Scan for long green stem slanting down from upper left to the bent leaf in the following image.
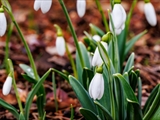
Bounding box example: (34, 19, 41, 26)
(5, 7, 39, 80)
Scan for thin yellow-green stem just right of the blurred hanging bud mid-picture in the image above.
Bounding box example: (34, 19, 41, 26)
(65, 43, 78, 78)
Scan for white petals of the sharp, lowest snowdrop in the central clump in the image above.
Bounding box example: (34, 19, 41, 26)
(89, 73, 104, 100)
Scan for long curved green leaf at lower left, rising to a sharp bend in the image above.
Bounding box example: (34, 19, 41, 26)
(25, 69, 51, 120)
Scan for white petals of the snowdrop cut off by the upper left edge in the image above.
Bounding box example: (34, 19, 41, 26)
(0, 13, 7, 36)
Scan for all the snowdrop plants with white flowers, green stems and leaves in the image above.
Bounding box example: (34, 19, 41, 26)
(0, 0, 160, 120)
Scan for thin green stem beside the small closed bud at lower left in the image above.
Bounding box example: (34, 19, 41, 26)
(8, 59, 24, 114)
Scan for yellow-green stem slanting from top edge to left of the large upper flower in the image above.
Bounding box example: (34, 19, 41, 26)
(96, 0, 109, 32)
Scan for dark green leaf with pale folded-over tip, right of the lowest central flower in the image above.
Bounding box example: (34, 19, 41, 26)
(113, 73, 138, 103)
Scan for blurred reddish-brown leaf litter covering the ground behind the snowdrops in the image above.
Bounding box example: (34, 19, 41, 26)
(0, 0, 160, 120)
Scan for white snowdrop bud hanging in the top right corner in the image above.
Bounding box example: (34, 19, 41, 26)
(144, 2, 157, 26)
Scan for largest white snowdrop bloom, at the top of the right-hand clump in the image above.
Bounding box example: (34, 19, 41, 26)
(109, 4, 126, 35)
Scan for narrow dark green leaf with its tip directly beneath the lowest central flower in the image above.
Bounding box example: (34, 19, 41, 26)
(94, 101, 113, 120)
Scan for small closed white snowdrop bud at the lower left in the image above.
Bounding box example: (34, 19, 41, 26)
(2, 76, 12, 95)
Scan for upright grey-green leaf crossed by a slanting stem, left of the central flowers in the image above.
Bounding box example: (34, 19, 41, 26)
(76, 42, 90, 84)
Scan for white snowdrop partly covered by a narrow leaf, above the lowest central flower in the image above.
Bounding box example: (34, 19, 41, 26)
(92, 41, 108, 66)
